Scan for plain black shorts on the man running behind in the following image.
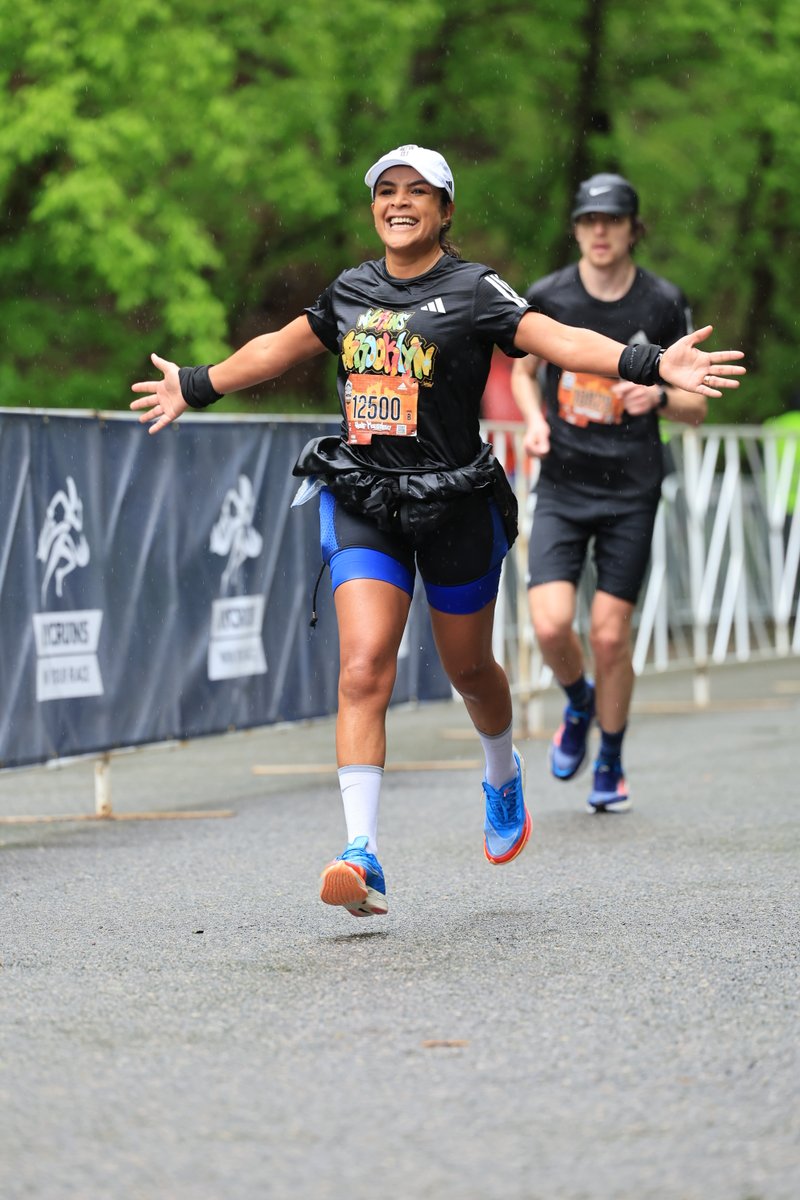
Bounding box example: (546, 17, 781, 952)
(528, 493, 658, 604)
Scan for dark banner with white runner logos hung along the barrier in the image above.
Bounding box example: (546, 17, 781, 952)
(0, 410, 450, 767)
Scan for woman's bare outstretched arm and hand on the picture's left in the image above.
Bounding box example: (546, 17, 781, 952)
(131, 314, 325, 433)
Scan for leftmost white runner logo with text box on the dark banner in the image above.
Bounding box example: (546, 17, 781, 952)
(34, 475, 103, 703)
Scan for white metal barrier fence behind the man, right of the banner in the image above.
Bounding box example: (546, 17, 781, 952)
(485, 422, 800, 730)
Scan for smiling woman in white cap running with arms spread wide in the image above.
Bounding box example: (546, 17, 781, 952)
(131, 144, 742, 917)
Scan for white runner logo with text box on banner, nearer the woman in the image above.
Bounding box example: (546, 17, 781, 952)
(209, 475, 266, 680)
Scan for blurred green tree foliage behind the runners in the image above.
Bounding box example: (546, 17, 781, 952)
(0, 0, 800, 420)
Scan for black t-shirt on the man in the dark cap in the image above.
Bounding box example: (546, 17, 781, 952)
(525, 264, 692, 502)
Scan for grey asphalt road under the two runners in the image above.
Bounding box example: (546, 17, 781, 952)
(0, 660, 800, 1200)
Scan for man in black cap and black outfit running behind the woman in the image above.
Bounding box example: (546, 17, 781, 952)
(511, 174, 706, 812)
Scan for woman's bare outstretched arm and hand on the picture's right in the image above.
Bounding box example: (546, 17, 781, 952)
(515, 312, 745, 396)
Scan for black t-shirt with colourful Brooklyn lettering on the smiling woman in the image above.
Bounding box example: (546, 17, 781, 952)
(306, 254, 528, 469)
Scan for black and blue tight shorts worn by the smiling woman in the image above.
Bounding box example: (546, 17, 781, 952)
(319, 488, 509, 613)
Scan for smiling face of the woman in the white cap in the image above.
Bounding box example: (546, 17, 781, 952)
(372, 167, 453, 257)
